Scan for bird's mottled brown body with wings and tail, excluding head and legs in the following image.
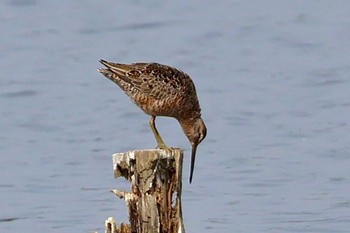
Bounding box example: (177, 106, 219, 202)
(99, 60, 200, 118)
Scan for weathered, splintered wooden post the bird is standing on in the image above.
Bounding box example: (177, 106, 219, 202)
(105, 149, 185, 233)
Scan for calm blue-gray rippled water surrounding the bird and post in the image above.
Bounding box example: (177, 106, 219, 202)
(0, 0, 350, 233)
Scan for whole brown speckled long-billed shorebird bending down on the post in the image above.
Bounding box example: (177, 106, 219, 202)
(97, 59, 207, 183)
